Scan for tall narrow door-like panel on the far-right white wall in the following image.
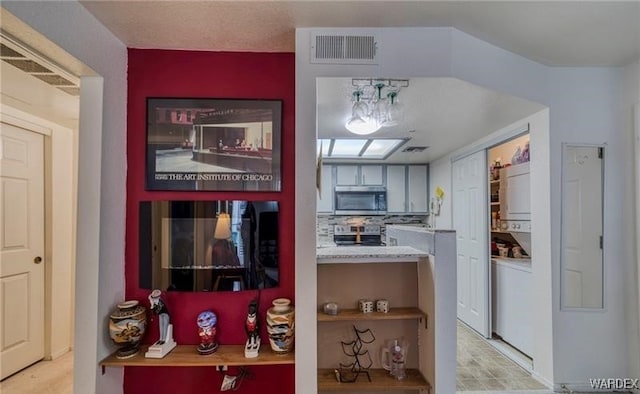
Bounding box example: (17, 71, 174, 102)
(562, 146, 603, 308)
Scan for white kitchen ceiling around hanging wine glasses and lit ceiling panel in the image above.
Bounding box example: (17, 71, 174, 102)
(316, 78, 544, 163)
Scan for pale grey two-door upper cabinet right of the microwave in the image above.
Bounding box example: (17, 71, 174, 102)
(387, 165, 428, 213)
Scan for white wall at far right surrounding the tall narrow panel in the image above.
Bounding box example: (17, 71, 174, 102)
(548, 68, 638, 389)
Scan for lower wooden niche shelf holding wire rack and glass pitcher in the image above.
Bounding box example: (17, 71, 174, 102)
(318, 369, 431, 391)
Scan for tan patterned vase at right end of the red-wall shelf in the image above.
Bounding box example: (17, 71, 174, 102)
(267, 298, 295, 353)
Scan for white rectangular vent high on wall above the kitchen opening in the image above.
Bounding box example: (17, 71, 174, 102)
(311, 34, 378, 64)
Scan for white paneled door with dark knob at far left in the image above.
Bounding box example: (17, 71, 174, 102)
(0, 123, 44, 379)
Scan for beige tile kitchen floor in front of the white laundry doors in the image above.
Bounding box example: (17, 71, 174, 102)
(456, 322, 551, 394)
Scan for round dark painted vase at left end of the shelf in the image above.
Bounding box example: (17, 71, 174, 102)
(109, 301, 147, 358)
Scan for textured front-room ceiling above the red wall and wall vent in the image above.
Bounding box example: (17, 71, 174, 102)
(80, 0, 640, 66)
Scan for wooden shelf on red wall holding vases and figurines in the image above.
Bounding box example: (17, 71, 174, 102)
(100, 345, 295, 368)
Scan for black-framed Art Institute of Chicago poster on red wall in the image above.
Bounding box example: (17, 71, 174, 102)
(146, 97, 282, 191)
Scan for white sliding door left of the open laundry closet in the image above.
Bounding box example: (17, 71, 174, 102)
(452, 150, 490, 337)
